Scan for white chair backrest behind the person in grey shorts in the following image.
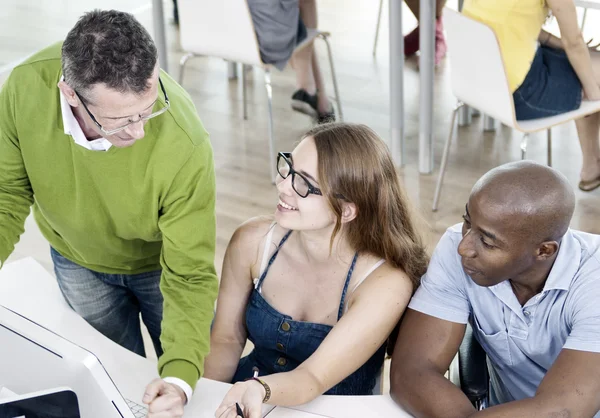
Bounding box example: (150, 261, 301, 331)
(177, 0, 262, 65)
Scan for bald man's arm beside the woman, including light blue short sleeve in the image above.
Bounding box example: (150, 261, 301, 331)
(390, 227, 475, 418)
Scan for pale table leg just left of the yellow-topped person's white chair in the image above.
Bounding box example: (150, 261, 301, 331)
(420, 0, 435, 174)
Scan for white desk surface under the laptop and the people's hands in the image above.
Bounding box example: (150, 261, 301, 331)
(0, 258, 410, 418)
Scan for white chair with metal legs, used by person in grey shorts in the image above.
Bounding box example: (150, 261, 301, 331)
(178, 0, 344, 179)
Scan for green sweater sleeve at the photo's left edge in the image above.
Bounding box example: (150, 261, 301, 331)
(0, 72, 34, 266)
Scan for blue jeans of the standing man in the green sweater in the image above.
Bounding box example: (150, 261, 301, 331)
(51, 248, 145, 356)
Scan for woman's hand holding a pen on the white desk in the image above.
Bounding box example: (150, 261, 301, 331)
(215, 380, 265, 418)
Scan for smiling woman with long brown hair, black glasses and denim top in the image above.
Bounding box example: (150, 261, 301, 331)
(205, 123, 428, 418)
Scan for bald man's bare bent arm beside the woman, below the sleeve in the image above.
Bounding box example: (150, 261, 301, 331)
(390, 309, 475, 418)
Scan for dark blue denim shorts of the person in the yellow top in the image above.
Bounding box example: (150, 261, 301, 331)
(513, 46, 582, 120)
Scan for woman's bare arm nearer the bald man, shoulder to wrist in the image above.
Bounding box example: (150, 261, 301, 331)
(261, 264, 412, 406)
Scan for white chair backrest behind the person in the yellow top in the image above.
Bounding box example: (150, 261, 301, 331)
(444, 8, 516, 126)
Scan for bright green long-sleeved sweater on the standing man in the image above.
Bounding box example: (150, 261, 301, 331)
(0, 44, 218, 388)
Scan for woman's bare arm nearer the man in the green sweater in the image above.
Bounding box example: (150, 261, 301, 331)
(204, 219, 268, 383)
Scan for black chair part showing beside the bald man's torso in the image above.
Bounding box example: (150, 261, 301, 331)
(455, 324, 490, 410)
